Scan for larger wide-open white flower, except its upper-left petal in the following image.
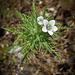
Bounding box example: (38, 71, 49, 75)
(42, 20, 58, 35)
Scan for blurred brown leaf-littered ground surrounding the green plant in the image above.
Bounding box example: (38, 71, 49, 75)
(0, 0, 75, 75)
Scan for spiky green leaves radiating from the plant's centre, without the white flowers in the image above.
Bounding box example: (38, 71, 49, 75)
(4, 1, 67, 63)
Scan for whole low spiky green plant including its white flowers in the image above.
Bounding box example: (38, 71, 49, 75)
(4, 1, 68, 62)
